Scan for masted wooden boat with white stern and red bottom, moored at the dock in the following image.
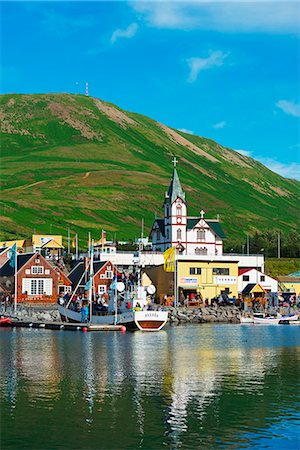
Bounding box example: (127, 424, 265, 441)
(58, 243, 168, 331)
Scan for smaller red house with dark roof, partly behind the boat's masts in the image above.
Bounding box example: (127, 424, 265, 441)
(68, 260, 121, 295)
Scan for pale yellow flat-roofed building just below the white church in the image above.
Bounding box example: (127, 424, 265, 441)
(177, 256, 238, 301)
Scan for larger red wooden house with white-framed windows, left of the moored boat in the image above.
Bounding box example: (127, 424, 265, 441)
(0, 253, 71, 303)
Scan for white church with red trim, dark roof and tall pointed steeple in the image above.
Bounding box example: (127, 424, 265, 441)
(150, 158, 225, 256)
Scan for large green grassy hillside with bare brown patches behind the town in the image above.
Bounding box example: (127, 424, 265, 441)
(0, 94, 300, 246)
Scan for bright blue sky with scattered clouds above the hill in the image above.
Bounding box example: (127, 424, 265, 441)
(0, 0, 300, 179)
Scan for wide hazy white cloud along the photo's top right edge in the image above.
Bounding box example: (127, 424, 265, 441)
(131, 0, 299, 34)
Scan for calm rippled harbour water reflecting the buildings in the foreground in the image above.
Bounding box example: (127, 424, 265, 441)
(0, 325, 300, 450)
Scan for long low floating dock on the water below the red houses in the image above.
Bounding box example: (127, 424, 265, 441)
(2, 319, 126, 332)
